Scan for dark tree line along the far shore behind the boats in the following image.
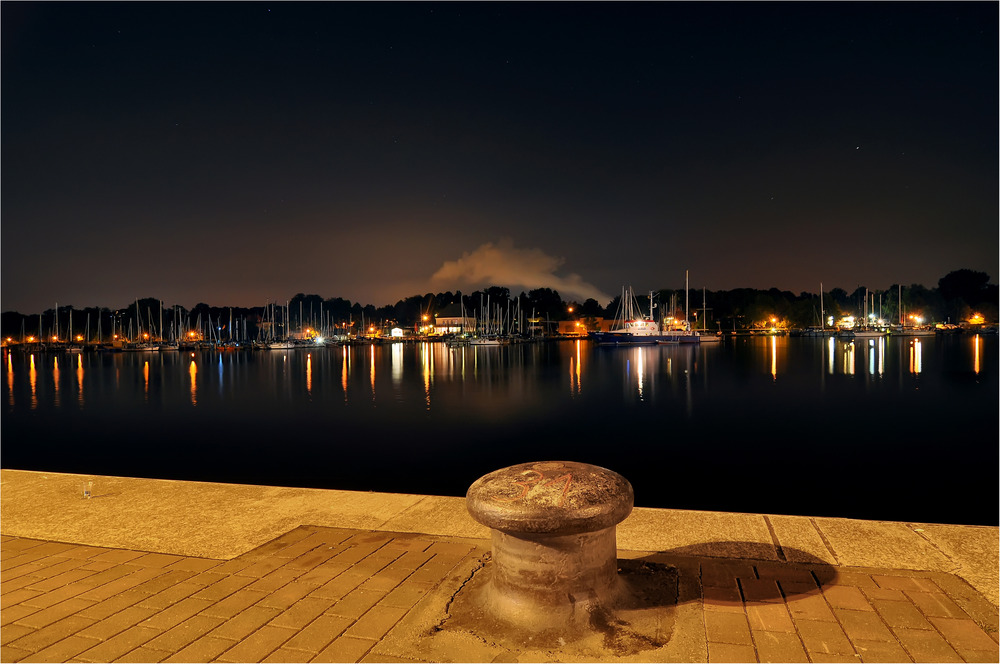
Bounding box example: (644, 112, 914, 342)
(0, 269, 998, 340)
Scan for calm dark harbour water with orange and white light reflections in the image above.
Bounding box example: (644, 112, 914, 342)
(2, 335, 1000, 525)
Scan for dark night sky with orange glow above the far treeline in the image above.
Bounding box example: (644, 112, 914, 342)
(0, 2, 1000, 313)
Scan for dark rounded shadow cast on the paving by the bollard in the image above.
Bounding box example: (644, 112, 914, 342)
(618, 541, 837, 609)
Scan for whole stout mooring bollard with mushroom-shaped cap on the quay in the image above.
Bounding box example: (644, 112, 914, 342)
(466, 461, 634, 631)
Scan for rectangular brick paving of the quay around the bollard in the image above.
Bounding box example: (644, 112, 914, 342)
(0, 526, 1000, 662)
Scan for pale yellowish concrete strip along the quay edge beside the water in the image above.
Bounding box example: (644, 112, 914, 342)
(0, 469, 1000, 606)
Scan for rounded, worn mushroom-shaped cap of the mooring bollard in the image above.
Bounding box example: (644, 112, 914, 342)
(466, 461, 634, 535)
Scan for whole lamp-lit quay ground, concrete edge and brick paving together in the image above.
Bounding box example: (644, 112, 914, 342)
(0, 470, 1000, 662)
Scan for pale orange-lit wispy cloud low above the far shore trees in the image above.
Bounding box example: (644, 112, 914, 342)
(431, 238, 611, 305)
